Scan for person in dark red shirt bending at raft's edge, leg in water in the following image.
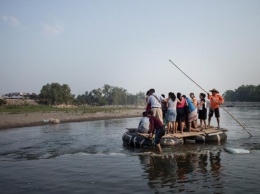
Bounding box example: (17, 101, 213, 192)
(147, 110, 165, 153)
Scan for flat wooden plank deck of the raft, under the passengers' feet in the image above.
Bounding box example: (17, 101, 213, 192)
(134, 127, 227, 139)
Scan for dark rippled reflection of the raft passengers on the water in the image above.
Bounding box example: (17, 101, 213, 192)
(139, 151, 224, 192)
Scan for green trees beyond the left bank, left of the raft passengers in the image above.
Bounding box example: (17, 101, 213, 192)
(39, 83, 145, 106)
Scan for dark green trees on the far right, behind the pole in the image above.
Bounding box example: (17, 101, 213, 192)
(224, 85, 260, 102)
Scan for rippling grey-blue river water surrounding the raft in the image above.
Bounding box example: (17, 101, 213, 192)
(0, 107, 260, 194)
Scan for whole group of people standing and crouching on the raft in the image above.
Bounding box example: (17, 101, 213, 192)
(138, 88, 224, 152)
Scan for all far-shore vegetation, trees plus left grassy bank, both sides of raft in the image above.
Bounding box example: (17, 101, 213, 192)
(0, 83, 260, 114)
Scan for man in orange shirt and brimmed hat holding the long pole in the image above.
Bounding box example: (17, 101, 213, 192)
(208, 89, 224, 129)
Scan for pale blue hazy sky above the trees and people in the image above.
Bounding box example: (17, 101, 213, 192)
(0, 0, 260, 96)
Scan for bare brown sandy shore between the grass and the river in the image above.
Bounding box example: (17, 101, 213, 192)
(0, 109, 143, 129)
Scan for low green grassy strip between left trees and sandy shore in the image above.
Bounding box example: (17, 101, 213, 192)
(0, 105, 138, 114)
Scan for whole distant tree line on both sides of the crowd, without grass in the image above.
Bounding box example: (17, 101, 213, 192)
(3, 83, 260, 106)
